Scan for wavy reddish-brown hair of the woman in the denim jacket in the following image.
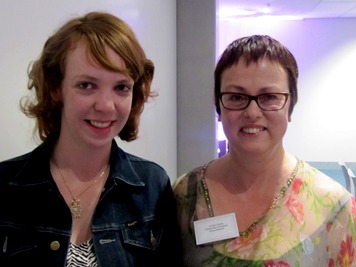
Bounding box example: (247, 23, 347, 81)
(20, 12, 154, 142)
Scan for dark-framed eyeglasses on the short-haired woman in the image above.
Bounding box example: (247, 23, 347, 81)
(218, 92, 291, 111)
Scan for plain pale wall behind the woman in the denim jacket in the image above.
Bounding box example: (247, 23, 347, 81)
(0, 0, 177, 179)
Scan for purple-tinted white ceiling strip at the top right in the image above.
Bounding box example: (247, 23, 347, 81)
(217, 0, 356, 19)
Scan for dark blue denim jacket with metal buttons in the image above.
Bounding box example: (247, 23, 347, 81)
(0, 141, 182, 267)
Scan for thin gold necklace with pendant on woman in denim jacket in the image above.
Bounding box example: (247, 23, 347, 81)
(53, 160, 108, 219)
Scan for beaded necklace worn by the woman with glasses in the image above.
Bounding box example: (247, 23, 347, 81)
(201, 159, 300, 237)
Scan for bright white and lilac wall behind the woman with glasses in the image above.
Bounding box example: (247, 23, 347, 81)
(217, 18, 356, 162)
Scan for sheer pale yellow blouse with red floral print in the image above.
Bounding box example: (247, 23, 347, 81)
(174, 161, 356, 267)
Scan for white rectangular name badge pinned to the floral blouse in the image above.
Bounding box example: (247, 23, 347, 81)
(194, 213, 239, 245)
